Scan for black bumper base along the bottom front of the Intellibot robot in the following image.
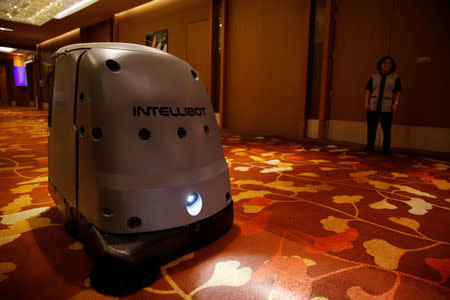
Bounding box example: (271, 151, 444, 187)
(79, 202, 233, 266)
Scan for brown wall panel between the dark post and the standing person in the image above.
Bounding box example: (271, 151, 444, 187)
(329, 0, 393, 121)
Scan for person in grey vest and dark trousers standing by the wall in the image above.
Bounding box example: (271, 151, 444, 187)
(363, 56, 402, 154)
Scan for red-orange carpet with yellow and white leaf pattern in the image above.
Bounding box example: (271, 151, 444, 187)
(0, 109, 450, 300)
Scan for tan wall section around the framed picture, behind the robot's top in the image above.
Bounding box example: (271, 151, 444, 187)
(116, 0, 212, 95)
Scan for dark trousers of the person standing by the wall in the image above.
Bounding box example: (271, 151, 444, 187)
(367, 110, 392, 152)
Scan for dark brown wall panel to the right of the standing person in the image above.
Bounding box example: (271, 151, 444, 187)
(390, 0, 450, 127)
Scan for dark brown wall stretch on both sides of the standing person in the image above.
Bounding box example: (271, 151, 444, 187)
(330, 0, 450, 128)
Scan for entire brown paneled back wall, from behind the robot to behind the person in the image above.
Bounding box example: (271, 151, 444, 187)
(29, 0, 450, 144)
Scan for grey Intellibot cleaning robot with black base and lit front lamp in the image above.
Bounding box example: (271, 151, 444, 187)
(48, 43, 233, 265)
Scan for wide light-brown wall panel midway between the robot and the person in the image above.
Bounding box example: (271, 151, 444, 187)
(223, 0, 309, 138)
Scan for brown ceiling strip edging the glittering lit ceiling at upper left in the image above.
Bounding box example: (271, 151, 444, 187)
(0, 0, 151, 49)
